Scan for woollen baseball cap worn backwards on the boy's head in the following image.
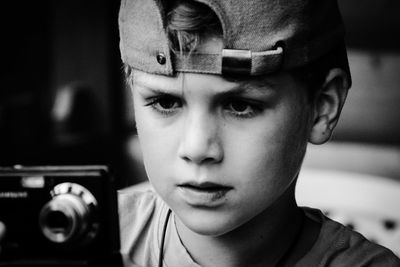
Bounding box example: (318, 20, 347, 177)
(119, 0, 350, 81)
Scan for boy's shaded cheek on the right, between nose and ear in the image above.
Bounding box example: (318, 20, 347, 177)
(228, 105, 307, 191)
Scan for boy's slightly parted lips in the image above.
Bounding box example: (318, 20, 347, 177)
(178, 182, 233, 208)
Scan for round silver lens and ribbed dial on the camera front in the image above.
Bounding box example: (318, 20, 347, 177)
(39, 183, 99, 244)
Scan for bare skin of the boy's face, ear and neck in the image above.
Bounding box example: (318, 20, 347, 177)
(132, 38, 349, 266)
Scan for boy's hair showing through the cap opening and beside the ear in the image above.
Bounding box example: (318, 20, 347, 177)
(125, 0, 332, 101)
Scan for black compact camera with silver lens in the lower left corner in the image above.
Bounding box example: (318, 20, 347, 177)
(0, 166, 121, 267)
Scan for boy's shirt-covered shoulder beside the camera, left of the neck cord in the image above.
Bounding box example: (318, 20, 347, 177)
(118, 183, 168, 266)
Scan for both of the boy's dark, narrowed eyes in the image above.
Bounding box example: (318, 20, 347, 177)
(145, 95, 263, 119)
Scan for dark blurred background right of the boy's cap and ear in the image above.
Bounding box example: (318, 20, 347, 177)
(333, 0, 400, 147)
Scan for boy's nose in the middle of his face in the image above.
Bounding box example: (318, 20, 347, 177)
(178, 113, 224, 164)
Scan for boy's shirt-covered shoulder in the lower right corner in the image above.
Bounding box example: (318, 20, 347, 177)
(300, 208, 400, 267)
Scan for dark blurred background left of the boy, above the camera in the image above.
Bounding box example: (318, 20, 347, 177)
(0, 0, 123, 170)
